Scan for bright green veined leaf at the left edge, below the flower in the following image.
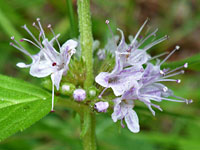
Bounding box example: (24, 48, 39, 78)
(0, 75, 51, 140)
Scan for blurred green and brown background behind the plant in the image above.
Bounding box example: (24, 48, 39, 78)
(0, 0, 200, 150)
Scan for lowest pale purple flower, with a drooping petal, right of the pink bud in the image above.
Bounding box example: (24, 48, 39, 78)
(112, 98, 140, 133)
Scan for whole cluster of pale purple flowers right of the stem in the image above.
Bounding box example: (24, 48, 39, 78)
(95, 20, 192, 133)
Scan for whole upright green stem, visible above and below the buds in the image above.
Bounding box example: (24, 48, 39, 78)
(78, 0, 96, 150)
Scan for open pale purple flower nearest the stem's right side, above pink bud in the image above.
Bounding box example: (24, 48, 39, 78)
(95, 53, 143, 97)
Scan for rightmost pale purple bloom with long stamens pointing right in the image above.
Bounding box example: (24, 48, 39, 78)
(122, 47, 192, 115)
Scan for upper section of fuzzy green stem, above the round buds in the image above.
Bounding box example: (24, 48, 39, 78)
(78, 0, 94, 89)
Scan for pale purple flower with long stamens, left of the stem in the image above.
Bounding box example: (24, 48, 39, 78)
(11, 18, 77, 111)
